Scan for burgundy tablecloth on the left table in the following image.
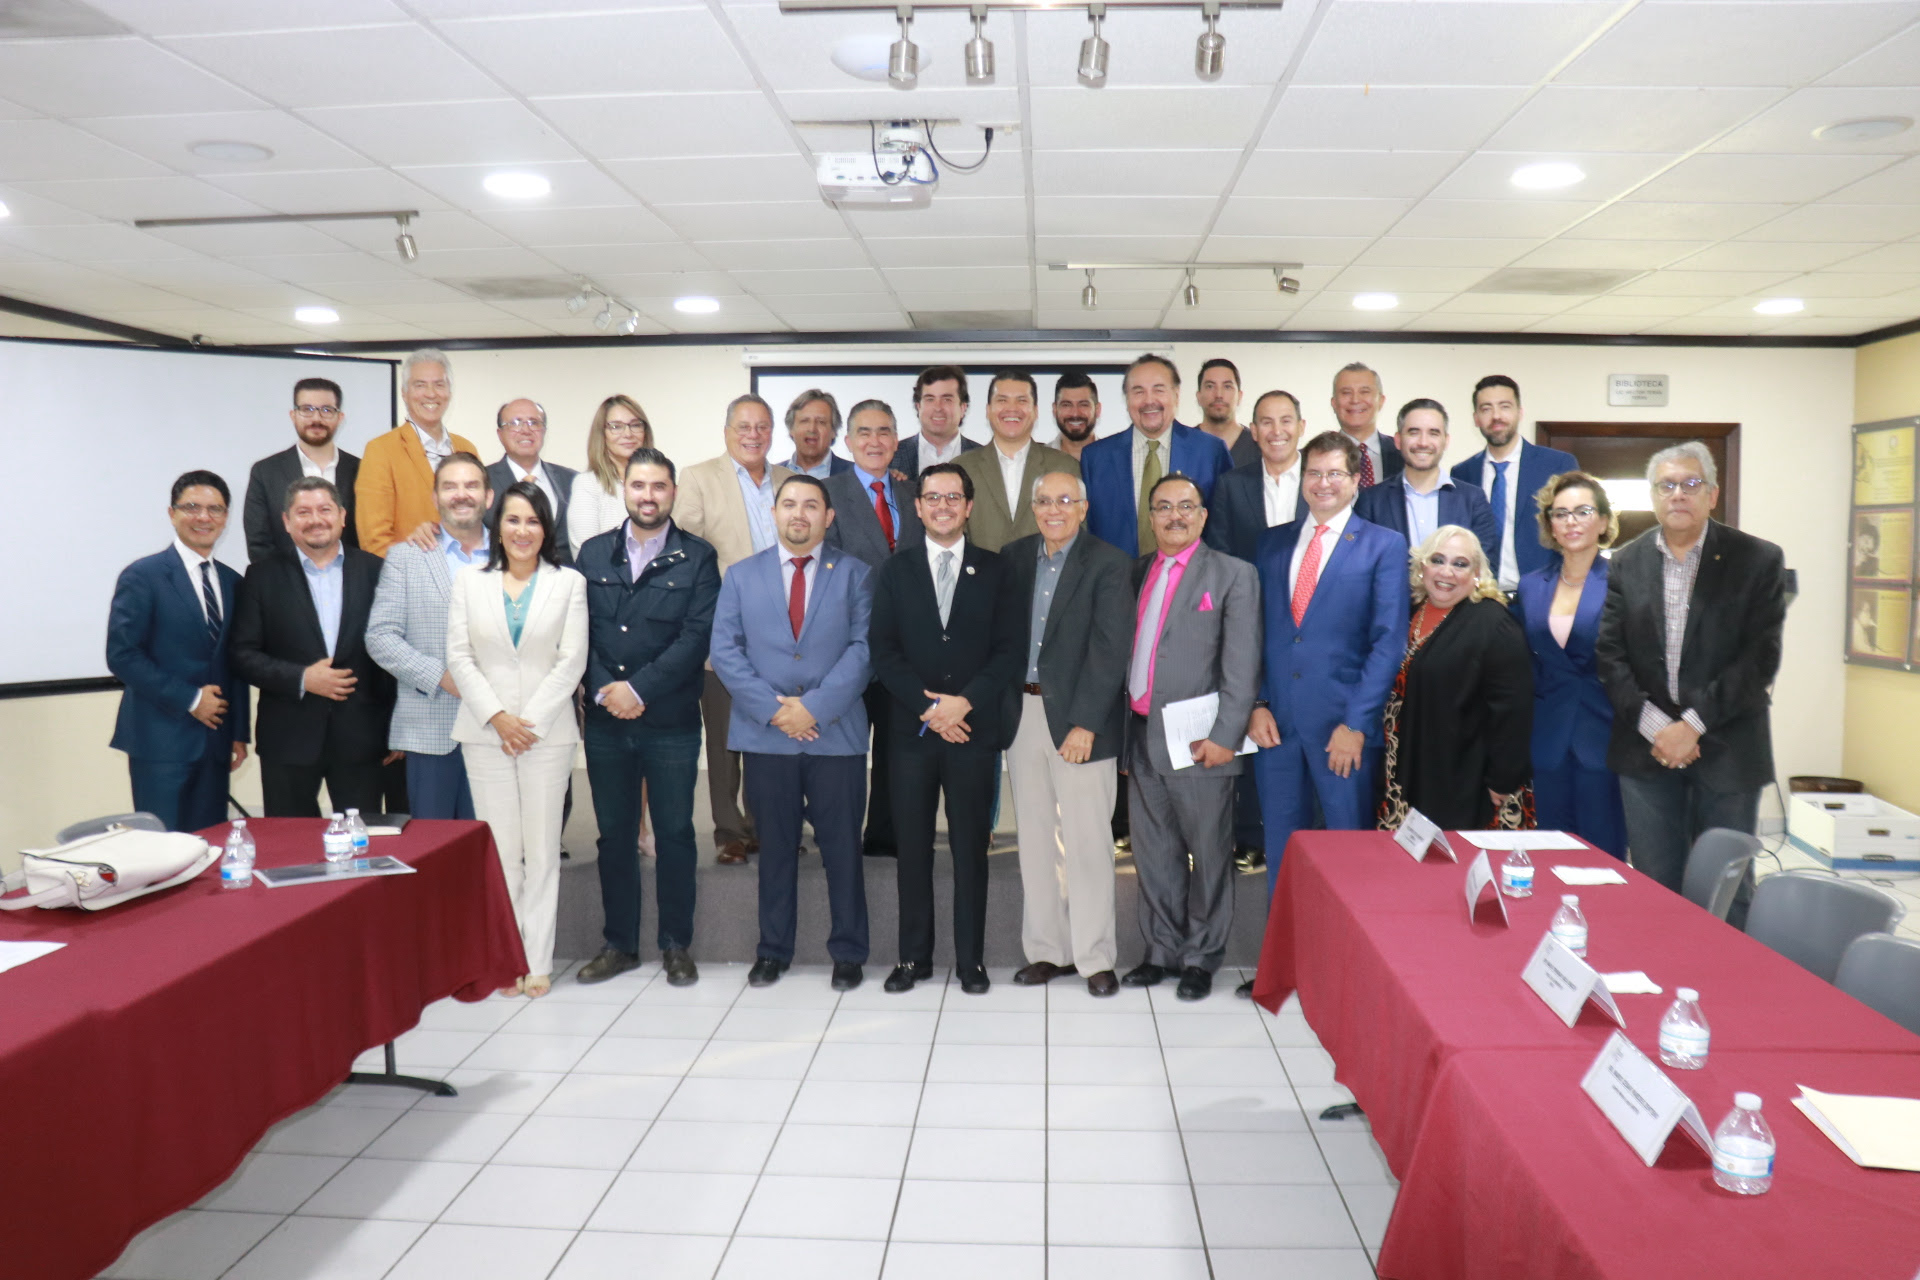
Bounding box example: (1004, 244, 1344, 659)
(0, 819, 526, 1280)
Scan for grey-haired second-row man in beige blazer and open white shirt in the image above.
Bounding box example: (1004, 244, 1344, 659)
(674, 393, 793, 865)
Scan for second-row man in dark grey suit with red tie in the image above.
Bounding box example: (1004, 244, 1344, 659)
(826, 399, 922, 858)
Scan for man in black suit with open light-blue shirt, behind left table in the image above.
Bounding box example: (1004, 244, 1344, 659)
(232, 476, 394, 818)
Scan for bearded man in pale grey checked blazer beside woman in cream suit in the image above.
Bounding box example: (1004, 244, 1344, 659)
(367, 453, 493, 819)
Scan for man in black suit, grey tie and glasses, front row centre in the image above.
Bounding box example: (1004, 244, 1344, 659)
(868, 462, 1027, 996)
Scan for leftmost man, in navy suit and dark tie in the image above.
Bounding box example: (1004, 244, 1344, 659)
(108, 470, 250, 831)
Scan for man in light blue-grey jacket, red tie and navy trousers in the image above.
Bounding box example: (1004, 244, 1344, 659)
(710, 476, 874, 990)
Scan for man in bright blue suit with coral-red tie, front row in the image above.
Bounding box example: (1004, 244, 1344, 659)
(1240, 432, 1409, 996)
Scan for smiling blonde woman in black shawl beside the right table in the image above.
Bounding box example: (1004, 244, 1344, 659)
(1380, 524, 1534, 831)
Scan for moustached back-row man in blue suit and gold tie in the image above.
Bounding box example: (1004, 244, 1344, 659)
(1081, 355, 1233, 557)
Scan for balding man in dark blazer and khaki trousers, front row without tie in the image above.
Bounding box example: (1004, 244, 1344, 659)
(1000, 472, 1133, 996)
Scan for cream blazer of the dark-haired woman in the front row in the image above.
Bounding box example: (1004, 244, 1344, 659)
(447, 564, 588, 747)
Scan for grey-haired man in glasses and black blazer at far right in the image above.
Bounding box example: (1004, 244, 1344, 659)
(1594, 441, 1788, 929)
